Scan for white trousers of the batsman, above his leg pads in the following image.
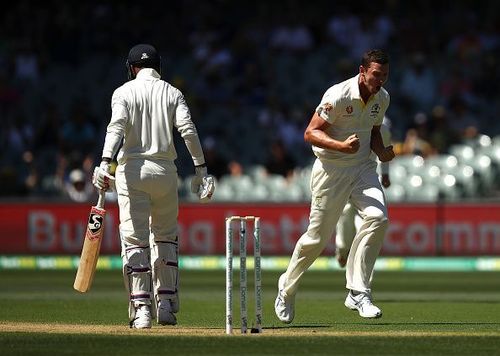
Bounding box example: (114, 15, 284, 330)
(115, 159, 179, 247)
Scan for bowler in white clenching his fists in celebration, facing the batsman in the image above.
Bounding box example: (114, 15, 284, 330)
(275, 50, 394, 323)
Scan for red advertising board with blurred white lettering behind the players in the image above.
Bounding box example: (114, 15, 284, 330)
(0, 203, 500, 256)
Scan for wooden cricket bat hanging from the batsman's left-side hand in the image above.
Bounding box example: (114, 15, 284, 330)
(73, 190, 106, 293)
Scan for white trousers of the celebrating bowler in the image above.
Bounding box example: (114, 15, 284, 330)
(283, 159, 388, 296)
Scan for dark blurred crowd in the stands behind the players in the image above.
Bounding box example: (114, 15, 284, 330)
(0, 0, 500, 201)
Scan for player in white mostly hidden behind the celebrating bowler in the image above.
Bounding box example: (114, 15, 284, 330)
(335, 116, 391, 268)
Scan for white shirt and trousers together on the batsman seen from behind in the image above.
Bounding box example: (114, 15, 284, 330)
(102, 68, 205, 246)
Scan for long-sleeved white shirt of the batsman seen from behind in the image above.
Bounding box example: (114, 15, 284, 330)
(102, 68, 205, 165)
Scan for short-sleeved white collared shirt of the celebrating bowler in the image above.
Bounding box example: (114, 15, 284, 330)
(312, 74, 390, 166)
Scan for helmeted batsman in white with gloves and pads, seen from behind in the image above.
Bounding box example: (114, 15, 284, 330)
(93, 44, 215, 329)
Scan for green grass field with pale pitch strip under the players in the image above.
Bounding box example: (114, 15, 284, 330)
(0, 269, 500, 355)
